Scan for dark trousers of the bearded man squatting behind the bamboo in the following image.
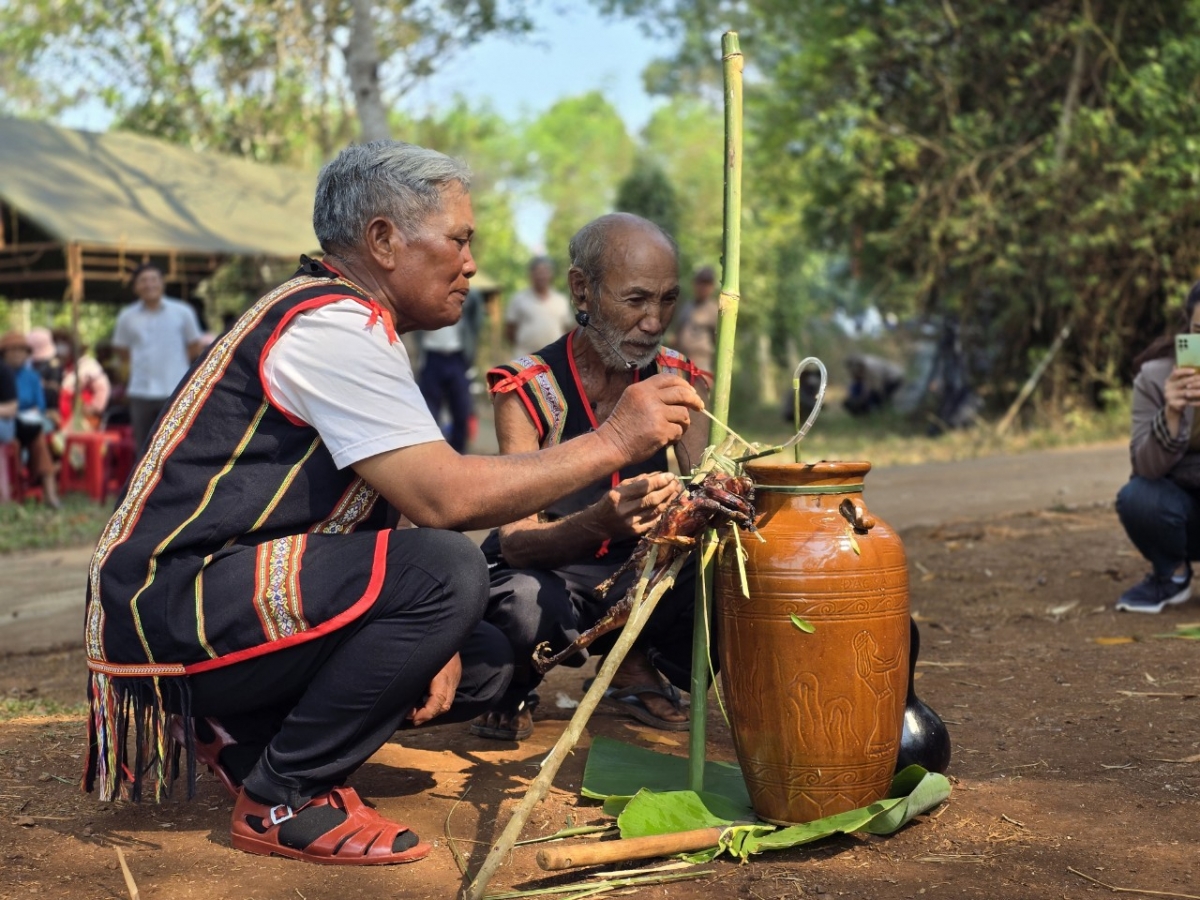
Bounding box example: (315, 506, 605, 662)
(485, 547, 700, 706)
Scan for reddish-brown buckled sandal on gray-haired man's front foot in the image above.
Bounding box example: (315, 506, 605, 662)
(230, 787, 432, 865)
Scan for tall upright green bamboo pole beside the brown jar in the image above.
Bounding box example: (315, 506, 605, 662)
(688, 31, 743, 791)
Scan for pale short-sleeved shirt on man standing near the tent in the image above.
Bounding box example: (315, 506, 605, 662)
(113, 296, 200, 400)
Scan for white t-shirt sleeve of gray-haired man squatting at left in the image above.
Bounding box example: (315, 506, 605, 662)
(263, 300, 445, 469)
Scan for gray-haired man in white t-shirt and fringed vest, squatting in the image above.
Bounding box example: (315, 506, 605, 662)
(85, 142, 702, 865)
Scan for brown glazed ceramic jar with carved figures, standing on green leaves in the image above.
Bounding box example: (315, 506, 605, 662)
(715, 457, 910, 824)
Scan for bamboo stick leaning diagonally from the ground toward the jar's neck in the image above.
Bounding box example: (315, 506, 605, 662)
(463, 551, 688, 900)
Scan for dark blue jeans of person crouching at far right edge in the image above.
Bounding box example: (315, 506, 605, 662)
(1117, 475, 1200, 578)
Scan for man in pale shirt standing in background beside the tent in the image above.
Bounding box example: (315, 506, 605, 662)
(113, 263, 204, 452)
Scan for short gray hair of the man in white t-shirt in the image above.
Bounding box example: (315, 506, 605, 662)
(312, 140, 470, 253)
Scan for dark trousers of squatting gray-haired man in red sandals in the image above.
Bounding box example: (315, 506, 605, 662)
(188, 528, 512, 809)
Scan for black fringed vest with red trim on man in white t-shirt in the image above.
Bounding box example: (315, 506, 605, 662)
(85, 258, 396, 799)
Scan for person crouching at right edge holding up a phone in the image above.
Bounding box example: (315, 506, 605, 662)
(1117, 282, 1200, 613)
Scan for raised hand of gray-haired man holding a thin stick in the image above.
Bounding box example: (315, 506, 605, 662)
(596, 374, 704, 464)
